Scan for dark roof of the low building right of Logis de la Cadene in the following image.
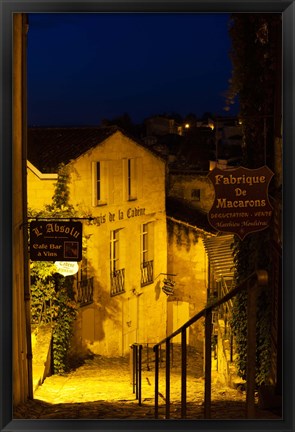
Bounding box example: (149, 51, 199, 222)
(166, 196, 216, 234)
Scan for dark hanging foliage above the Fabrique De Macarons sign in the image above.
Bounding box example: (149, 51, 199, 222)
(225, 13, 281, 168)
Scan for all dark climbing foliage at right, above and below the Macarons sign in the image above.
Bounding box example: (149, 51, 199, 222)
(225, 13, 281, 385)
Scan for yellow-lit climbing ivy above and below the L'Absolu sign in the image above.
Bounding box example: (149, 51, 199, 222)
(28, 166, 77, 374)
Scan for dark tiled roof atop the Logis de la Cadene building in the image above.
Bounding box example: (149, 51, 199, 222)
(27, 126, 153, 173)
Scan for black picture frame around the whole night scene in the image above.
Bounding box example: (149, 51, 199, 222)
(0, 0, 295, 432)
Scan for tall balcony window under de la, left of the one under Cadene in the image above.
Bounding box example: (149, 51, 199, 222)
(110, 230, 125, 296)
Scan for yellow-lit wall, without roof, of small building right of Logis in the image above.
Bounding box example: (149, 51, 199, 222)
(167, 219, 208, 345)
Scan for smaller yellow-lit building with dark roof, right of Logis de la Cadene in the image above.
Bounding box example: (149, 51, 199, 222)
(166, 196, 216, 347)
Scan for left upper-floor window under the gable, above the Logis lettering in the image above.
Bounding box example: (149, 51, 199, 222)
(92, 161, 108, 207)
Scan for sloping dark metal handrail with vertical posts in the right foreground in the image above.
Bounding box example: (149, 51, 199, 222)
(153, 270, 268, 419)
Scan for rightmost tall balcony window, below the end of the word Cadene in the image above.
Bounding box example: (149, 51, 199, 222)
(140, 222, 154, 286)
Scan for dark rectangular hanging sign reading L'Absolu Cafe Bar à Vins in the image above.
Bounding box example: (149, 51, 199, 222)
(30, 220, 82, 261)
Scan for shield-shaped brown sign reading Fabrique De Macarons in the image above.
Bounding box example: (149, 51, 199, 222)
(208, 166, 274, 240)
